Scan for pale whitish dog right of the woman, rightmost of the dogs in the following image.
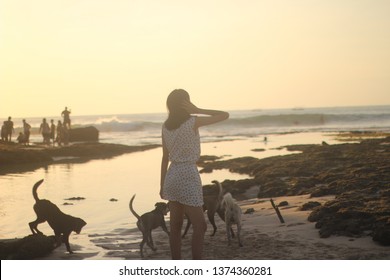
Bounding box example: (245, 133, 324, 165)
(221, 193, 242, 247)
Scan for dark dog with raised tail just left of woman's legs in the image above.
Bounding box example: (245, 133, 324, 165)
(129, 195, 169, 258)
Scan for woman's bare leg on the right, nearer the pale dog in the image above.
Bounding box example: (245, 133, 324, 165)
(184, 206, 207, 260)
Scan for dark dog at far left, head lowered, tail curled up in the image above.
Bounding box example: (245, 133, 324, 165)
(29, 179, 87, 253)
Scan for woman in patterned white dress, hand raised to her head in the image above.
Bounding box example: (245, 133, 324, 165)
(160, 89, 229, 259)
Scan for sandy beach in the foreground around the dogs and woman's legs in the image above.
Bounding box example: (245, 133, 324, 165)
(32, 192, 390, 260)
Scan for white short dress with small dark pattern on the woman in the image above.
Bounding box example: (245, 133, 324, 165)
(162, 117, 203, 207)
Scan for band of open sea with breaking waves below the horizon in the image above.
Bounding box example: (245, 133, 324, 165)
(8, 105, 390, 145)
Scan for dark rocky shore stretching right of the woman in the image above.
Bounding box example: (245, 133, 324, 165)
(200, 137, 390, 245)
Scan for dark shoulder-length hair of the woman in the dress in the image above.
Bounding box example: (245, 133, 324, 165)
(165, 89, 191, 130)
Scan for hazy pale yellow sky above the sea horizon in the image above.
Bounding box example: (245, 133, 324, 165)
(0, 0, 390, 118)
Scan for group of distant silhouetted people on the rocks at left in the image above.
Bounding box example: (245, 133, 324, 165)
(1, 107, 71, 145)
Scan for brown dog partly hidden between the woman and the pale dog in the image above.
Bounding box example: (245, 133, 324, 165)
(182, 180, 225, 238)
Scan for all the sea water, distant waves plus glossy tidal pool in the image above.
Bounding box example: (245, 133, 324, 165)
(0, 106, 390, 259)
